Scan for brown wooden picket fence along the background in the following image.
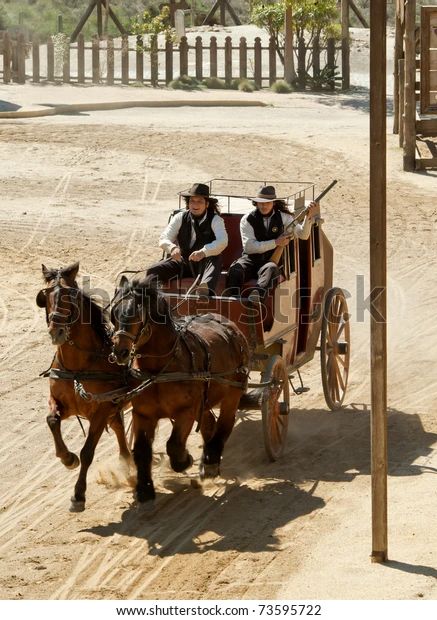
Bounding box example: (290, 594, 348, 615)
(0, 32, 341, 89)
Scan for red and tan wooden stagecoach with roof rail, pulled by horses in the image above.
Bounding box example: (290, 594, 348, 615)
(164, 179, 350, 461)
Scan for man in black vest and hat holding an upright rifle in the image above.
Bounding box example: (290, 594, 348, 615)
(226, 185, 316, 301)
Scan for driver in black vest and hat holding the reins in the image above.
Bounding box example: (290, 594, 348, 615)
(147, 183, 228, 297)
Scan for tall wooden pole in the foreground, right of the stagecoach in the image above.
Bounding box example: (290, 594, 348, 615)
(370, 2, 387, 562)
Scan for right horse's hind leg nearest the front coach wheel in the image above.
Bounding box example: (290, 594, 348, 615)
(200, 390, 241, 478)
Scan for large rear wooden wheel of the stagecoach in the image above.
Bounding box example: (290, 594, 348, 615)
(320, 288, 350, 411)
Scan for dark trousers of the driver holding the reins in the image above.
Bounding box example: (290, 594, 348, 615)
(146, 256, 222, 295)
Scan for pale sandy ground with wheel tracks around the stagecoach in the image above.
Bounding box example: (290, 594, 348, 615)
(0, 41, 437, 599)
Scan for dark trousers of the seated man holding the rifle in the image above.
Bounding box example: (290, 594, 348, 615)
(226, 254, 281, 297)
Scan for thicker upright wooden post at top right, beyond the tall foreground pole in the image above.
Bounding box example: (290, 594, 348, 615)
(404, 0, 416, 172)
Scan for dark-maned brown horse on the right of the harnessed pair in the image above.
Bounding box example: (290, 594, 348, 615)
(112, 277, 249, 502)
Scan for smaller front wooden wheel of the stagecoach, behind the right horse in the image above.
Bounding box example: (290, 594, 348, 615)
(261, 355, 290, 461)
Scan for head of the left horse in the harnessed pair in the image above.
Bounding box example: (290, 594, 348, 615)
(36, 263, 79, 346)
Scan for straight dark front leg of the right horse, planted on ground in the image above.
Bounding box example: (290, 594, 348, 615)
(132, 412, 156, 503)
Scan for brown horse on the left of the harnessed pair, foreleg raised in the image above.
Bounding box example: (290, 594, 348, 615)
(36, 263, 131, 512)
